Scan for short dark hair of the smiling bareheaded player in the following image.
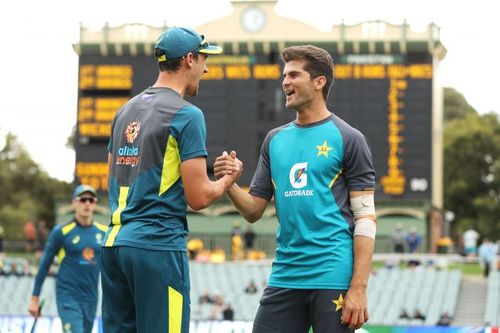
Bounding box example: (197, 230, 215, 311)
(281, 45, 334, 101)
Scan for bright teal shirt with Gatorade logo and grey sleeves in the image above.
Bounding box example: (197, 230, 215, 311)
(250, 114, 375, 289)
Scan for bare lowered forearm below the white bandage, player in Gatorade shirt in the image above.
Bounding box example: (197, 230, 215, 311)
(351, 236, 375, 289)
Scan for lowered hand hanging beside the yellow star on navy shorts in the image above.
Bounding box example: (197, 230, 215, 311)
(341, 286, 368, 330)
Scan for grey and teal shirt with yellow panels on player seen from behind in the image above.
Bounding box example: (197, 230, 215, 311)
(103, 87, 207, 251)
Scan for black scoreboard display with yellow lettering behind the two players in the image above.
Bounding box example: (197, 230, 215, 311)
(75, 53, 433, 201)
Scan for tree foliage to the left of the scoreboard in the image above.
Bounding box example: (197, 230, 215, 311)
(0, 133, 71, 240)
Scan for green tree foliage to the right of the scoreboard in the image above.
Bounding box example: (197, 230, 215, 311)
(444, 89, 500, 239)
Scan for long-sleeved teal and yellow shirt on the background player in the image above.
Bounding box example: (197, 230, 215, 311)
(33, 219, 108, 303)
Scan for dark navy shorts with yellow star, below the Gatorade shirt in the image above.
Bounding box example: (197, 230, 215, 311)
(252, 287, 352, 333)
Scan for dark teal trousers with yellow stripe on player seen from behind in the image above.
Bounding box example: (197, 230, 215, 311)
(101, 246, 190, 333)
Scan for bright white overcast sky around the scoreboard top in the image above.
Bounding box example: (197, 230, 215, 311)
(0, 0, 500, 181)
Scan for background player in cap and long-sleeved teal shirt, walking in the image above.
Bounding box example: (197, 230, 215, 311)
(28, 185, 107, 333)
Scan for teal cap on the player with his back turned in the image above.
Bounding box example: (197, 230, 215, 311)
(155, 27, 222, 61)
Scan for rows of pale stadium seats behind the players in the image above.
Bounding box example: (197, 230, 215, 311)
(0, 254, 500, 332)
